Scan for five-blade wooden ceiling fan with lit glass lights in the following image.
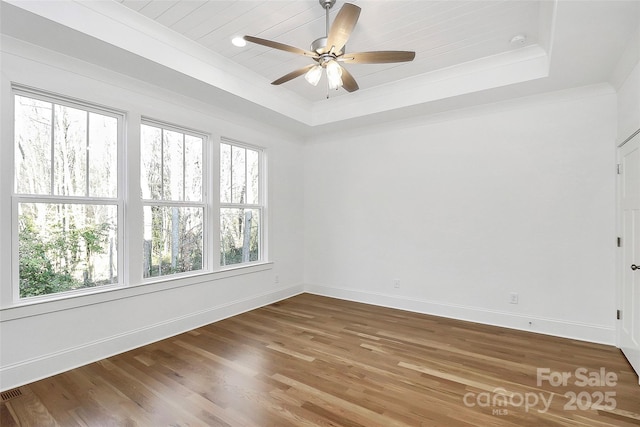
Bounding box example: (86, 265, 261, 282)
(244, 0, 416, 92)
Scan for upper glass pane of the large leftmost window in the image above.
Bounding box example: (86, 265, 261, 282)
(15, 95, 118, 198)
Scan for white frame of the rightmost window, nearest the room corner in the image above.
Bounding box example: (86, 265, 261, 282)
(216, 137, 268, 271)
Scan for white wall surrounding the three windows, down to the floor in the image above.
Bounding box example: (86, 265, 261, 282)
(0, 38, 303, 390)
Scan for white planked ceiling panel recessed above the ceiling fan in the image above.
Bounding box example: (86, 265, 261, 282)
(116, 0, 540, 101)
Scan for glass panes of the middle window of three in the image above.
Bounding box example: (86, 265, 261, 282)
(140, 121, 207, 277)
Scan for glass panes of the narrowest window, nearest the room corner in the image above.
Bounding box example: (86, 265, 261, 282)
(220, 141, 264, 266)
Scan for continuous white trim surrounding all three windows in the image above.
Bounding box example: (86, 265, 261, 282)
(0, 83, 273, 310)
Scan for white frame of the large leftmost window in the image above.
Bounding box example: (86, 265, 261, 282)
(10, 84, 128, 305)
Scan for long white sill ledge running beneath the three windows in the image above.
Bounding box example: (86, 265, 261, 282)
(0, 262, 273, 322)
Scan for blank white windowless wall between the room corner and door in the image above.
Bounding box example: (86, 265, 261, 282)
(305, 85, 616, 344)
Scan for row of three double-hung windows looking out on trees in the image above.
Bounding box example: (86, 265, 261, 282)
(11, 85, 266, 300)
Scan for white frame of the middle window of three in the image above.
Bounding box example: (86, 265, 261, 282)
(137, 116, 210, 284)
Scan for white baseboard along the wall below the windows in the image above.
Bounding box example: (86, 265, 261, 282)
(0, 285, 304, 391)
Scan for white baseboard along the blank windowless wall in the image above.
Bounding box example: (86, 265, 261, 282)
(305, 285, 616, 345)
